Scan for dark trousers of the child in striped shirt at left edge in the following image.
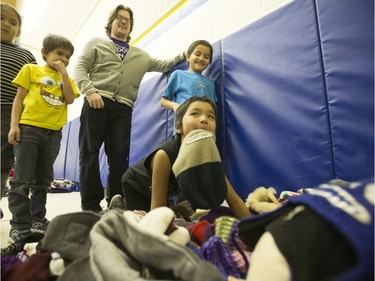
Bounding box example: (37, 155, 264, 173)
(0, 104, 14, 198)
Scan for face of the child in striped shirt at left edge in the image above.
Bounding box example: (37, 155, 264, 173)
(1, 6, 20, 44)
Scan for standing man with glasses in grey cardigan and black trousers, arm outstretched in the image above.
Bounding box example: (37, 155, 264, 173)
(74, 5, 184, 212)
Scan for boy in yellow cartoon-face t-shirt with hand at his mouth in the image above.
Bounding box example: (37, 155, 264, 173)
(8, 34, 79, 242)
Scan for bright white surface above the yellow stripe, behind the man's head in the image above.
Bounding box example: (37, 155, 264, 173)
(17, 0, 180, 61)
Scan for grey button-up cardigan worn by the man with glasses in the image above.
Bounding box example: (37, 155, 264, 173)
(73, 38, 184, 107)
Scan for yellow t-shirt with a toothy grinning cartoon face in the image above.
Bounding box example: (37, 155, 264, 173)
(12, 64, 79, 130)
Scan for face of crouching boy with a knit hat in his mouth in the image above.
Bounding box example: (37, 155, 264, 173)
(176, 101, 216, 140)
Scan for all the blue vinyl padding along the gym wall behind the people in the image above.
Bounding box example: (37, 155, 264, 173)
(55, 0, 374, 199)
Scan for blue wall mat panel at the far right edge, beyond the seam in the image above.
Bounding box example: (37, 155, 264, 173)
(317, 0, 374, 181)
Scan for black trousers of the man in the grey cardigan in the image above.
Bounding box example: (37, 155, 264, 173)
(79, 98, 132, 211)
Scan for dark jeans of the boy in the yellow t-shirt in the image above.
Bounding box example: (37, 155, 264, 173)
(8, 125, 62, 229)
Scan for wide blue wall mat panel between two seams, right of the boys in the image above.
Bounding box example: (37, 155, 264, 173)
(223, 1, 333, 196)
